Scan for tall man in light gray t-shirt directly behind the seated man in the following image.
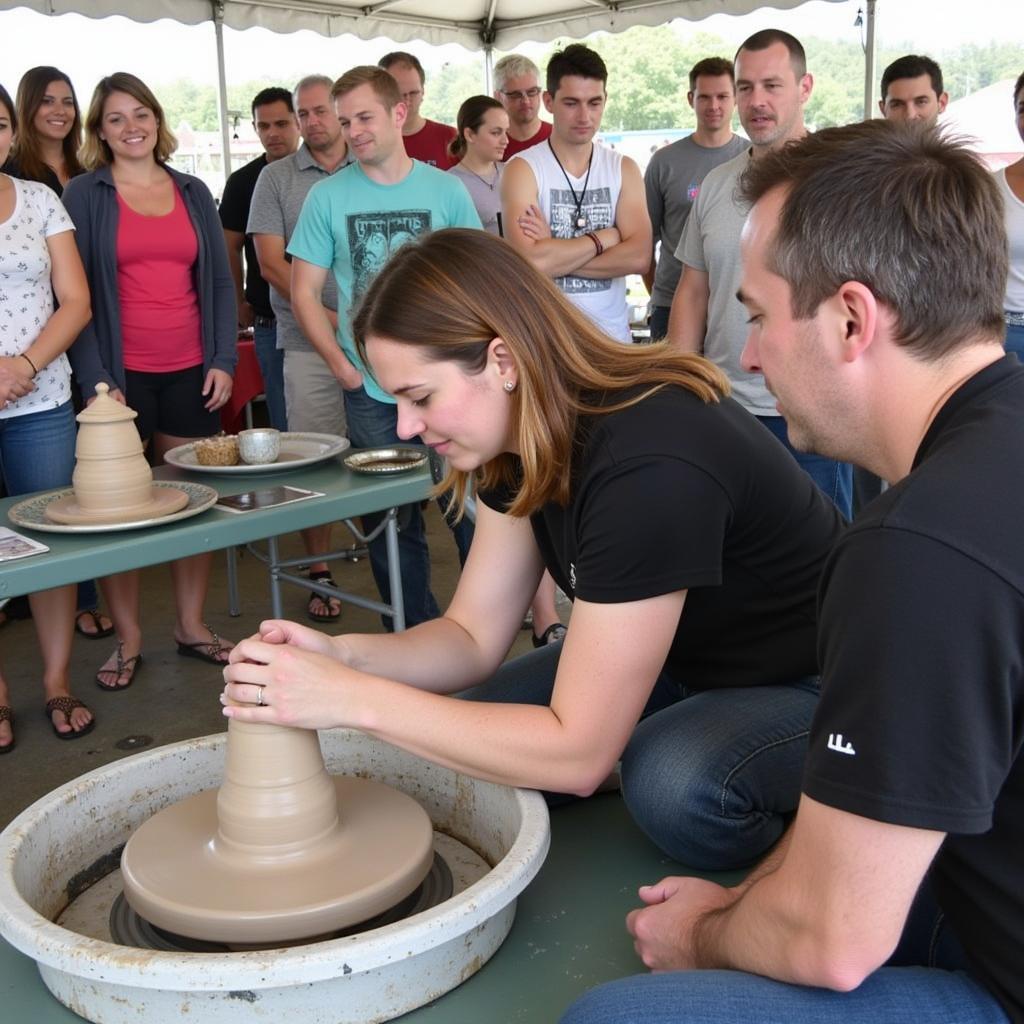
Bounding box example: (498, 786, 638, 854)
(668, 29, 852, 518)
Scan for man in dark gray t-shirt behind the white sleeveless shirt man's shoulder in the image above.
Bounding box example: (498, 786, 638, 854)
(643, 57, 749, 341)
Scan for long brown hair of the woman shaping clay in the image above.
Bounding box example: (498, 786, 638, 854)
(352, 228, 729, 516)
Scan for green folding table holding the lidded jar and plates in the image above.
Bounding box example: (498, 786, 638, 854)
(0, 459, 432, 629)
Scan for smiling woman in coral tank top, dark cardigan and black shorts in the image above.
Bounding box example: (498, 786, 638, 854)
(63, 72, 237, 690)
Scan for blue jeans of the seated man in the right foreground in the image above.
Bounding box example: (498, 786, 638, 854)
(561, 880, 1009, 1024)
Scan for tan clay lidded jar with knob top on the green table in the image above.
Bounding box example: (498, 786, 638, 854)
(72, 384, 153, 519)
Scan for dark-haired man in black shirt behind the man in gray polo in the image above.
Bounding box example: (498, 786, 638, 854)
(220, 87, 299, 430)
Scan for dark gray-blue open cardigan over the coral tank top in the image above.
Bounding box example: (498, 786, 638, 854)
(62, 167, 238, 398)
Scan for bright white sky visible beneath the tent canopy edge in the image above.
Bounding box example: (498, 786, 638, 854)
(0, 0, 1024, 101)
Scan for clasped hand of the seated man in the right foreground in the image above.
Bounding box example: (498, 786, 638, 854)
(626, 877, 736, 971)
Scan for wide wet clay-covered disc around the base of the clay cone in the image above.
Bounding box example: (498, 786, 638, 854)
(121, 777, 433, 942)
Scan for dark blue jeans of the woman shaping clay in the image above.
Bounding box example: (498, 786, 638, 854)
(461, 643, 818, 870)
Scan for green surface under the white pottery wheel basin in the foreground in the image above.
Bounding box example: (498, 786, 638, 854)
(0, 795, 740, 1024)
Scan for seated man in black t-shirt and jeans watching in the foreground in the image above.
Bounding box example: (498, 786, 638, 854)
(565, 121, 1024, 1024)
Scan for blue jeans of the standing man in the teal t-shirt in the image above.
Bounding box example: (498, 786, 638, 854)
(345, 387, 473, 629)
